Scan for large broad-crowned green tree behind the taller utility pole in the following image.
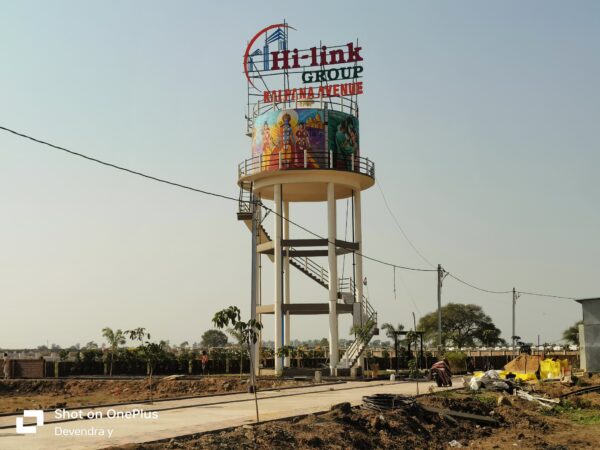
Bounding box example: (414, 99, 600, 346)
(417, 303, 505, 348)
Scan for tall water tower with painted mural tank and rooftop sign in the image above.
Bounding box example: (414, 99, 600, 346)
(238, 24, 377, 375)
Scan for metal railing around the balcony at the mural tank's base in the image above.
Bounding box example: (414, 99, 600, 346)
(238, 150, 375, 178)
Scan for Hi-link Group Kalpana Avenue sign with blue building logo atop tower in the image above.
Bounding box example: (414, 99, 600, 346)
(244, 23, 363, 102)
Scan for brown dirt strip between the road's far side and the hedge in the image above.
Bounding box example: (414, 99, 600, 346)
(0, 377, 310, 413)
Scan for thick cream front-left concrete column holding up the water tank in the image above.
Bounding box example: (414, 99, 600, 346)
(273, 184, 283, 375)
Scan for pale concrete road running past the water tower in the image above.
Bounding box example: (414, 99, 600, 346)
(0, 381, 450, 450)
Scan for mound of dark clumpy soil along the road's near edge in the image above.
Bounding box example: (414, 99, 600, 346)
(118, 404, 489, 450)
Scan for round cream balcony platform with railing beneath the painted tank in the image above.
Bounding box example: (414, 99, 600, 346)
(238, 151, 375, 202)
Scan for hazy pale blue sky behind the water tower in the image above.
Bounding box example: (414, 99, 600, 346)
(0, 1, 600, 347)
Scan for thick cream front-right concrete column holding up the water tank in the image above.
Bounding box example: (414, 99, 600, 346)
(327, 183, 339, 375)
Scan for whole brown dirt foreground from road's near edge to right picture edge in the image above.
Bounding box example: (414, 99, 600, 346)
(109, 379, 600, 450)
